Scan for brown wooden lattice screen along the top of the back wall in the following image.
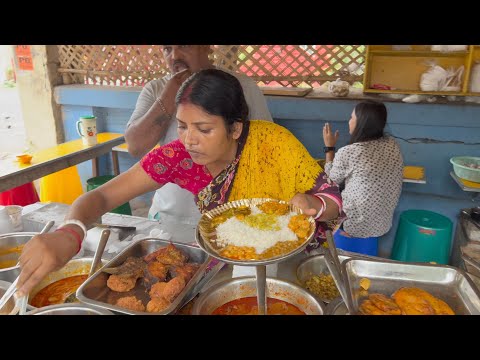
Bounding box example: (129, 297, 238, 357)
(58, 45, 365, 87)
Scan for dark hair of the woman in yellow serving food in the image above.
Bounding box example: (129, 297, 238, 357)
(175, 69, 248, 133)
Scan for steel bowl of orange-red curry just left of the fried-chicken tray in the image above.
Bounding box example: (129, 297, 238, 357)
(28, 257, 106, 309)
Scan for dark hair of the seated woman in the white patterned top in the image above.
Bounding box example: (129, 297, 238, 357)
(350, 100, 387, 144)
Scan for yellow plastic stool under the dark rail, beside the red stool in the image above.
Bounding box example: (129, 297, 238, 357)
(40, 166, 83, 205)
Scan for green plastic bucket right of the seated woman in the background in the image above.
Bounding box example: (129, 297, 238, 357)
(391, 210, 453, 264)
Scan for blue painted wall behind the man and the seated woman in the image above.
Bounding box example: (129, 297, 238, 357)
(55, 85, 480, 256)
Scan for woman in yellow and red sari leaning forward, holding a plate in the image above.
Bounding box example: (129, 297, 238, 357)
(18, 69, 341, 294)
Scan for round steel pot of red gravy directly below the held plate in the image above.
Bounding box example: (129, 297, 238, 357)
(192, 276, 324, 315)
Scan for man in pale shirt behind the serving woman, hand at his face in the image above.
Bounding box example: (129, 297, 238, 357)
(125, 45, 272, 225)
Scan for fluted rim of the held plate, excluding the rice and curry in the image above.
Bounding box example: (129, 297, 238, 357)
(195, 198, 315, 266)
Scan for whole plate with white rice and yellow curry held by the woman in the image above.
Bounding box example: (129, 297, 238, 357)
(196, 198, 315, 266)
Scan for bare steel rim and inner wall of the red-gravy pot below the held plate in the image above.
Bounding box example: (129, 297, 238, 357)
(192, 276, 324, 315)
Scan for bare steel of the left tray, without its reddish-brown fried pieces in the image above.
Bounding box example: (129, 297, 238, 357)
(76, 238, 212, 315)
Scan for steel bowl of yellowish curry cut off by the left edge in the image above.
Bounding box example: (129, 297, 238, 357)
(0, 232, 38, 282)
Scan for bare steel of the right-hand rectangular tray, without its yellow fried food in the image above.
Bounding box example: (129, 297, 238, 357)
(342, 259, 480, 315)
